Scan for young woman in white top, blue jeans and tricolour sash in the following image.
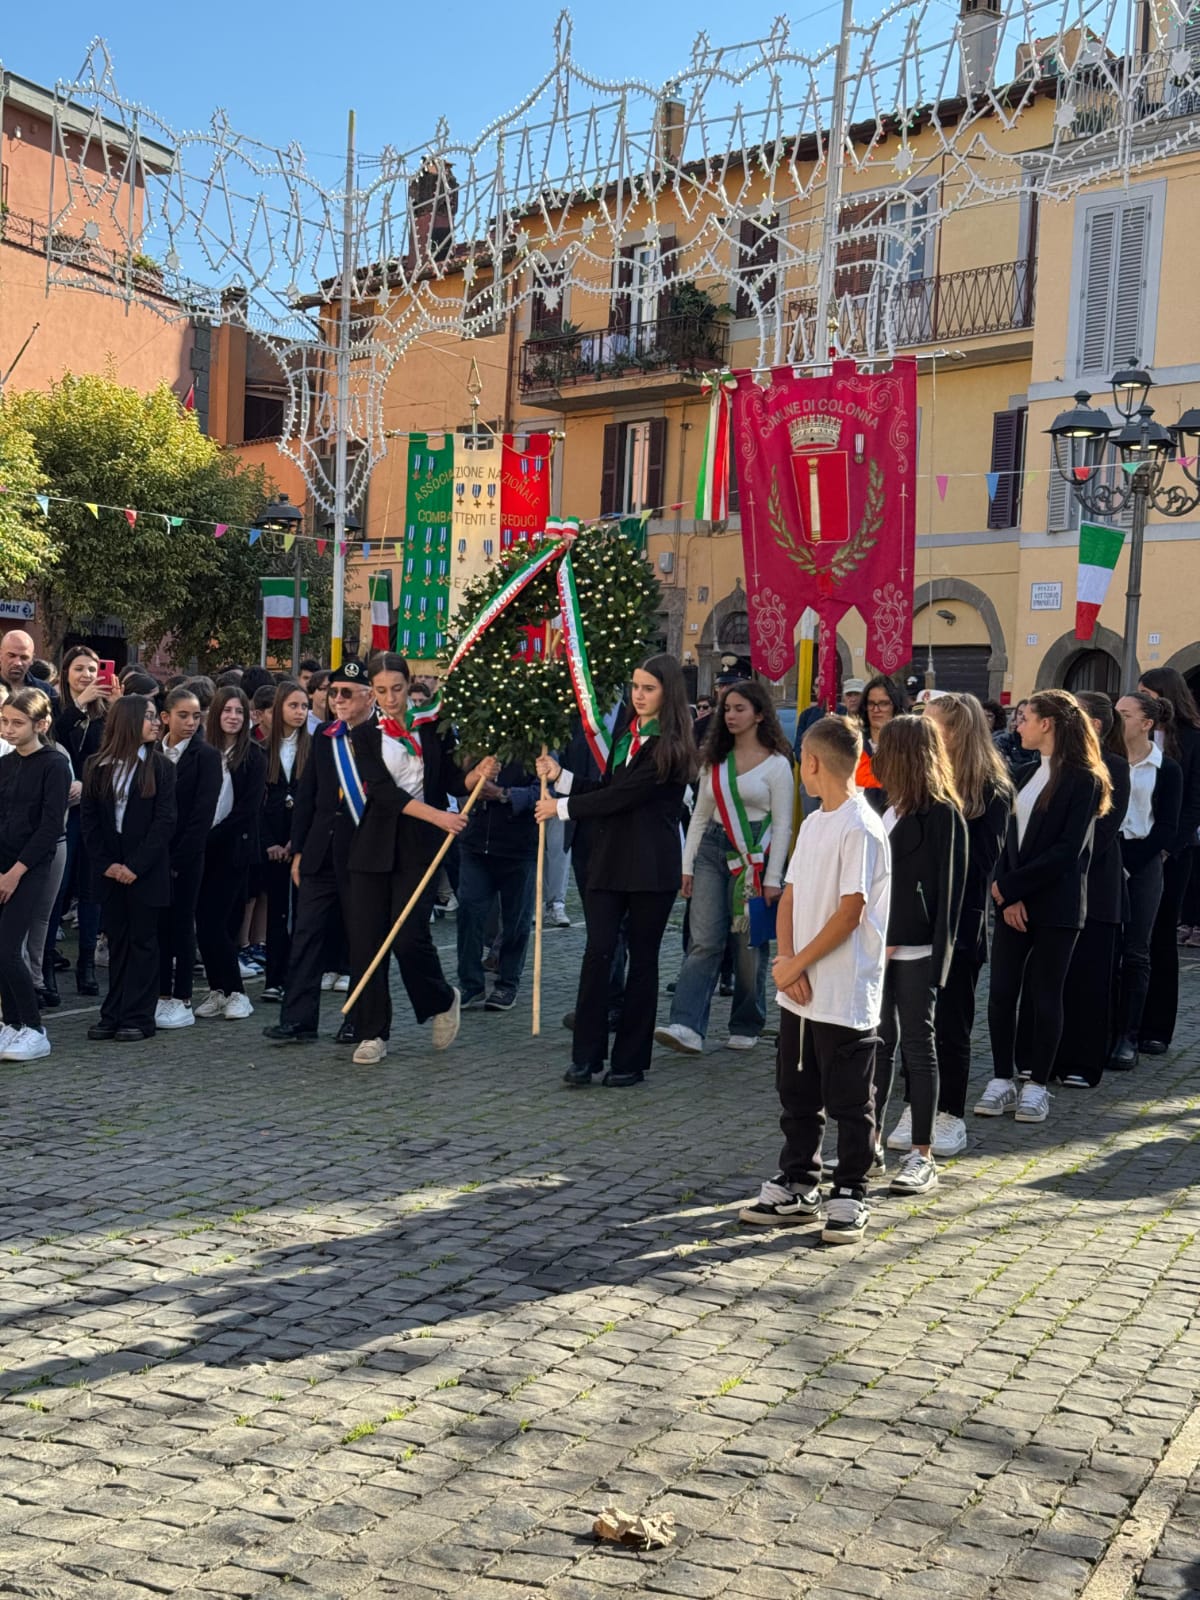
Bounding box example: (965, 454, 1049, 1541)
(654, 683, 794, 1056)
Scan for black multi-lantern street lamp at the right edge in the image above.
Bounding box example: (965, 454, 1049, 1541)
(1046, 362, 1200, 691)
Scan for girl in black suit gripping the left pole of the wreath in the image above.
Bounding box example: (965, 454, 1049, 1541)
(349, 653, 499, 1066)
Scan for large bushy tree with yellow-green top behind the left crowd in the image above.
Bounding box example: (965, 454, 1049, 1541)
(6, 374, 328, 666)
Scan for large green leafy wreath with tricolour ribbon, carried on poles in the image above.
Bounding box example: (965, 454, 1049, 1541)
(438, 526, 659, 770)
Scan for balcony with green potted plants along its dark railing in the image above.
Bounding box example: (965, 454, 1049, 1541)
(517, 315, 730, 411)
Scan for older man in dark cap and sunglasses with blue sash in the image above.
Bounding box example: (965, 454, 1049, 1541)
(262, 659, 374, 1045)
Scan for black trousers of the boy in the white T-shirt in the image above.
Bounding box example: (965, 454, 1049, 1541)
(774, 1006, 878, 1200)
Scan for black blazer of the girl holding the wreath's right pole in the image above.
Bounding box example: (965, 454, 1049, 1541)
(566, 738, 686, 893)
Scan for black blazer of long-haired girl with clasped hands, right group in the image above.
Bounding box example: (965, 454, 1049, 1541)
(995, 766, 1099, 928)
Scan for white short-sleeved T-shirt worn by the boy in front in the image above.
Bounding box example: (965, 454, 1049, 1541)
(776, 795, 891, 1030)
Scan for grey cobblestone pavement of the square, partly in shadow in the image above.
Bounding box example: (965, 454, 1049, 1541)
(0, 902, 1200, 1600)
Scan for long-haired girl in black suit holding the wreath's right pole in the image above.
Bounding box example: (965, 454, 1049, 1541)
(534, 656, 696, 1088)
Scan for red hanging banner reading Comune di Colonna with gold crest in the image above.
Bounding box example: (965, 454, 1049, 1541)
(733, 360, 917, 701)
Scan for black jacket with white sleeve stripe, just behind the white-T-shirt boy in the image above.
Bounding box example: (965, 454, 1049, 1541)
(888, 800, 966, 987)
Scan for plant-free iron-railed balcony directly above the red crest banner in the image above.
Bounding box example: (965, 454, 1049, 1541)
(789, 261, 1037, 358)
